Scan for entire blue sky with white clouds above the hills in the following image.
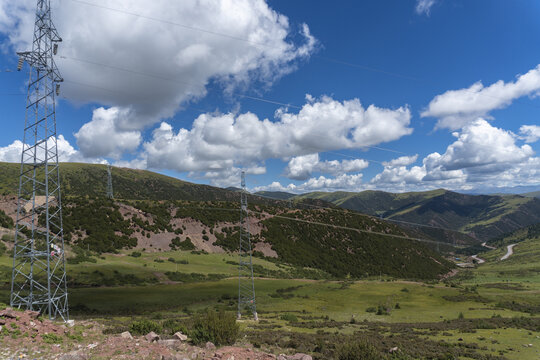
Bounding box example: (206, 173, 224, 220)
(0, 0, 540, 192)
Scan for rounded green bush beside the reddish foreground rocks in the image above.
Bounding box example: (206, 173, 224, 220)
(190, 310, 240, 346)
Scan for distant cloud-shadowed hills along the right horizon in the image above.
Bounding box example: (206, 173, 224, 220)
(295, 189, 540, 241)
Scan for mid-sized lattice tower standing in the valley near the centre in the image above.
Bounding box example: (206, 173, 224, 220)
(238, 171, 259, 321)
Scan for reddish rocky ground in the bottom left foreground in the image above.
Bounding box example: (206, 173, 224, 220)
(0, 308, 311, 360)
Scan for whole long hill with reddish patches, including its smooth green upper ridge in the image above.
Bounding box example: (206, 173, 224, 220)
(0, 163, 453, 279)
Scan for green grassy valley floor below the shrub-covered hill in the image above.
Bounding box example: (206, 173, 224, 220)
(0, 241, 540, 360)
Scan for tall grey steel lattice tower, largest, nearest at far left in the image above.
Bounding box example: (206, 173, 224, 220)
(10, 0, 69, 321)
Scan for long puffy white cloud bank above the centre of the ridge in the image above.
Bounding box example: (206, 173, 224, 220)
(130, 97, 412, 183)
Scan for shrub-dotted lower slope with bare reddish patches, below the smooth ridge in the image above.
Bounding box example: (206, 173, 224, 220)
(47, 198, 452, 279)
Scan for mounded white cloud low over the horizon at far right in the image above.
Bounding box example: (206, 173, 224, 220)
(371, 119, 540, 191)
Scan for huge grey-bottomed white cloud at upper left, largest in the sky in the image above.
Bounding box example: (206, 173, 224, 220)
(0, 0, 317, 136)
